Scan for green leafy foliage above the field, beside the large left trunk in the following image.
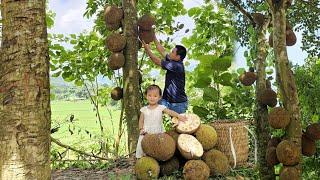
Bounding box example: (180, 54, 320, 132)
(50, 32, 112, 86)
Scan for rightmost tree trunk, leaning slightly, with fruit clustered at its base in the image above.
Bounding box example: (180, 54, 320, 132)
(268, 0, 302, 178)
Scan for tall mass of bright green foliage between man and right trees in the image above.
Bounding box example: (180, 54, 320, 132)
(183, 1, 253, 121)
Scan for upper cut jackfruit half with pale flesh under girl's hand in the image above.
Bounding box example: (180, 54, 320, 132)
(172, 113, 201, 134)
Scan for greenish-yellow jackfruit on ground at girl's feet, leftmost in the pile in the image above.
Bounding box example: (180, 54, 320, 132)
(134, 157, 160, 180)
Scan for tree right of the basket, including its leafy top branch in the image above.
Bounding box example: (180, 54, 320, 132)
(221, 0, 275, 179)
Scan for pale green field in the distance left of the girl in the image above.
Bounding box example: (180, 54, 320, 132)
(51, 100, 126, 158)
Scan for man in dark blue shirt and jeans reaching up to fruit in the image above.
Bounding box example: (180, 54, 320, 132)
(142, 37, 188, 114)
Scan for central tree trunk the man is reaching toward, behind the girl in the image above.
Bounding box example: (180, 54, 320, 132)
(122, 0, 141, 153)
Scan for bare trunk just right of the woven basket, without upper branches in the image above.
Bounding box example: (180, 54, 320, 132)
(255, 21, 275, 180)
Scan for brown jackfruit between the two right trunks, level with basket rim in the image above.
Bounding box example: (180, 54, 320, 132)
(268, 107, 290, 129)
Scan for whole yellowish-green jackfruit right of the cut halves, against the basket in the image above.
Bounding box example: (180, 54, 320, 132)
(195, 124, 218, 151)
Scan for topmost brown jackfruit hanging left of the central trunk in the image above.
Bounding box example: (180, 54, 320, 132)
(104, 5, 123, 24)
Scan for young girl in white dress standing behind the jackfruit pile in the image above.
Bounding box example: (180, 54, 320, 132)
(136, 84, 187, 158)
